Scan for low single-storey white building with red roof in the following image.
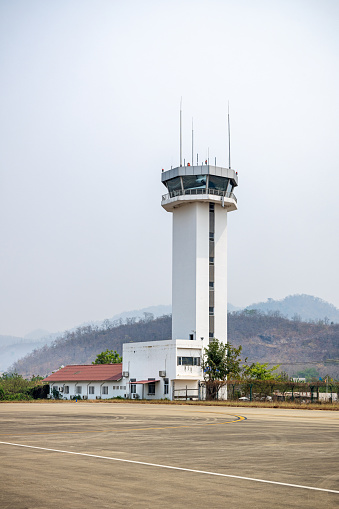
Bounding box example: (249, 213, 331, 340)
(44, 363, 129, 399)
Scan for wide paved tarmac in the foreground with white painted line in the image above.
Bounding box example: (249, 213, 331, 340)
(0, 402, 339, 509)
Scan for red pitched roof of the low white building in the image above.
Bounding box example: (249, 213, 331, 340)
(44, 363, 122, 382)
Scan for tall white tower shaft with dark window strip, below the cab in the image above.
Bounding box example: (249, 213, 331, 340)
(172, 202, 227, 346)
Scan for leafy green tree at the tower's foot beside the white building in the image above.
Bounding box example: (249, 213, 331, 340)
(202, 339, 242, 399)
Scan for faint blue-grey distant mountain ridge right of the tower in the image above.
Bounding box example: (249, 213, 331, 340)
(246, 294, 339, 323)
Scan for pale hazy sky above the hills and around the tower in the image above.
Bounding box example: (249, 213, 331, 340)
(0, 0, 339, 335)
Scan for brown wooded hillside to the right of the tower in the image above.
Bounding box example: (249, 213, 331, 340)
(228, 310, 339, 378)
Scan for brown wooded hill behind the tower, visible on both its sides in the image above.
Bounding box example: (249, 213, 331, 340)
(11, 311, 339, 378)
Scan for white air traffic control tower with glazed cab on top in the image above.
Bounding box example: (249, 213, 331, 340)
(161, 164, 238, 348)
